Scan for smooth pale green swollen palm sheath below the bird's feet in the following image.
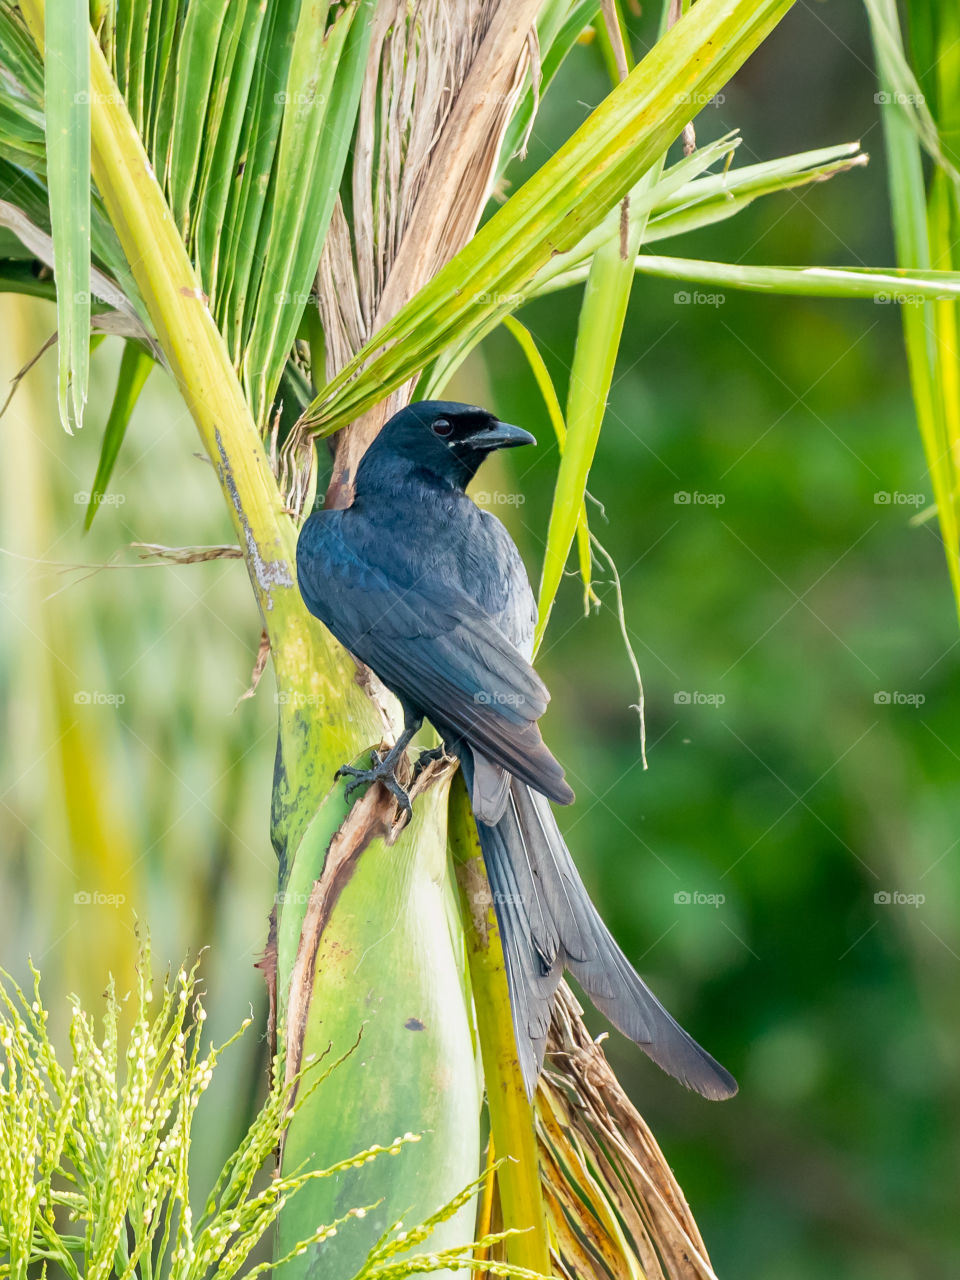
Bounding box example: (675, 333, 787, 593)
(276, 771, 481, 1280)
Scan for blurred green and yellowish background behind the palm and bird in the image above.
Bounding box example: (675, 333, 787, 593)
(0, 4, 960, 1280)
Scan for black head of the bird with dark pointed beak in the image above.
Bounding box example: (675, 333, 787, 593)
(361, 401, 536, 489)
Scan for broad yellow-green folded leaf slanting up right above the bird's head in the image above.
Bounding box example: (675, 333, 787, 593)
(305, 0, 788, 433)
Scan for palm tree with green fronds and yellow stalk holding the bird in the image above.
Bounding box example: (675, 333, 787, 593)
(0, 0, 960, 1277)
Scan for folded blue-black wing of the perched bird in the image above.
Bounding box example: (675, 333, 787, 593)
(298, 522, 573, 804)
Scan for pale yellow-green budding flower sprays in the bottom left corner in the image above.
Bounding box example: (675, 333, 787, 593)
(0, 945, 545, 1280)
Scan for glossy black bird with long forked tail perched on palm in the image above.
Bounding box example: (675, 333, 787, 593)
(297, 401, 737, 1100)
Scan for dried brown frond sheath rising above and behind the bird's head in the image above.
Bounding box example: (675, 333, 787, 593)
(285, 0, 539, 511)
